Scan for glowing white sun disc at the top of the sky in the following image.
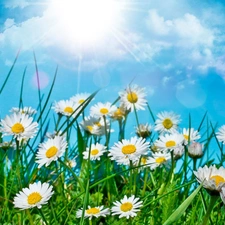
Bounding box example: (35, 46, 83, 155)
(49, 0, 120, 43)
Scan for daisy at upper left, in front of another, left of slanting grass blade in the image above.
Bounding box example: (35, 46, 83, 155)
(52, 100, 79, 117)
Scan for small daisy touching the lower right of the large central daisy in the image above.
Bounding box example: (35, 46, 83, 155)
(146, 152, 171, 170)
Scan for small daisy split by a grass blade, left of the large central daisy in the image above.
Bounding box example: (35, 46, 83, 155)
(83, 143, 106, 160)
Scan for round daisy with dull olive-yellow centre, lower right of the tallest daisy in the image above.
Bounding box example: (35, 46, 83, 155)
(155, 111, 180, 133)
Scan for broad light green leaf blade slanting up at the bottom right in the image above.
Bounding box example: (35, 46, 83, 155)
(163, 185, 202, 225)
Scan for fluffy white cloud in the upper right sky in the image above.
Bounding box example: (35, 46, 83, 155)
(146, 9, 214, 48)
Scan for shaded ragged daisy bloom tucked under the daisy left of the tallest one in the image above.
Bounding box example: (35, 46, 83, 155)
(80, 116, 110, 136)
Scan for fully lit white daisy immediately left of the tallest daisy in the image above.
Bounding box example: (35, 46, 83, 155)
(90, 102, 117, 117)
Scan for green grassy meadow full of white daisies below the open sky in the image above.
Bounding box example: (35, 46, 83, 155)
(0, 55, 225, 225)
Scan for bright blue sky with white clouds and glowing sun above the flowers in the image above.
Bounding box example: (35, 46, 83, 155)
(0, 0, 225, 139)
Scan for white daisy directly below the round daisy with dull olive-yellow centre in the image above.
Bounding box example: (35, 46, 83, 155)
(155, 133, 184, 151)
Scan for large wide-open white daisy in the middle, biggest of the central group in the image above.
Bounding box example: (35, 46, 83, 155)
(109, 137, 149, 165)
